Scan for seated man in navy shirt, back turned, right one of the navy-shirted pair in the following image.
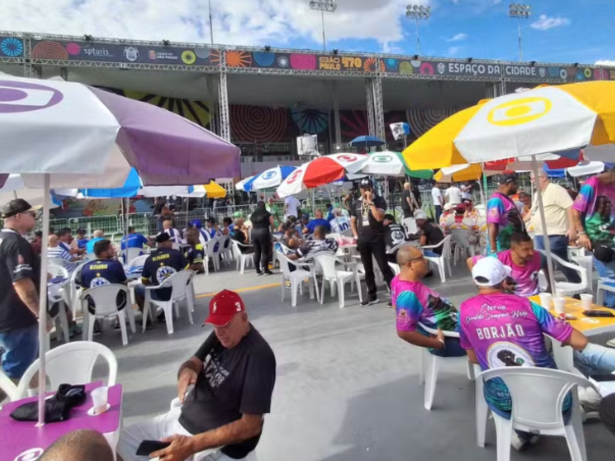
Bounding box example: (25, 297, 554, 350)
(135, 232, 188, 324)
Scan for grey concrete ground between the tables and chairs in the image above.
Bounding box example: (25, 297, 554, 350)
(88, 264, 615, 461)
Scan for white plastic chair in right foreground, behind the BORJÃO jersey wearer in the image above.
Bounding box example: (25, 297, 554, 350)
(476, 367, 598, 461)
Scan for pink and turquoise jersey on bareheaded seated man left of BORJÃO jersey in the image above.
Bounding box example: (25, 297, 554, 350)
(391, 275, 458, 331)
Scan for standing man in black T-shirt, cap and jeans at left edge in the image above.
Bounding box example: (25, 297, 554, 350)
(0, 199, 52, 380)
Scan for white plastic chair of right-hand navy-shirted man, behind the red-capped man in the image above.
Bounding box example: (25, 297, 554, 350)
(143, 269, 194, 335)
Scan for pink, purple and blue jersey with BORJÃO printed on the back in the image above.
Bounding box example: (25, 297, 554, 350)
(459, 293, 572, 411)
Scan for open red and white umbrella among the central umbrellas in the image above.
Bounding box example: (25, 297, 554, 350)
(278, 154, 369, 198)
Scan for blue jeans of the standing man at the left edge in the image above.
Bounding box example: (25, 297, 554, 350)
(0, 324, 38, 379)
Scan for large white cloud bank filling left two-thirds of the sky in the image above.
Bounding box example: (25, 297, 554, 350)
(0, 0, 431, 46)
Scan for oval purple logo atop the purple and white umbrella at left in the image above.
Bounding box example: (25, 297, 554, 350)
(0, 80, 64, 114)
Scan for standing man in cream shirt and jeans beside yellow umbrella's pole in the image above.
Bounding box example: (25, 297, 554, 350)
(531, 170, 581, 283)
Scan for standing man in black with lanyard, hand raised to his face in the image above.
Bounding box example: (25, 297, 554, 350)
(350, 179, 394, 306)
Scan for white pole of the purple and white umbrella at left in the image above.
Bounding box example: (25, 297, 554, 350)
(37, 173, 51, 427)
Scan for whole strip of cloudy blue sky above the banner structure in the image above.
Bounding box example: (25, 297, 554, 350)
(0, 0, 615, 65)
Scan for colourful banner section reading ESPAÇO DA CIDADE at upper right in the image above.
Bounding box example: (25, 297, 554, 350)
(382, 58, 615, 82)
